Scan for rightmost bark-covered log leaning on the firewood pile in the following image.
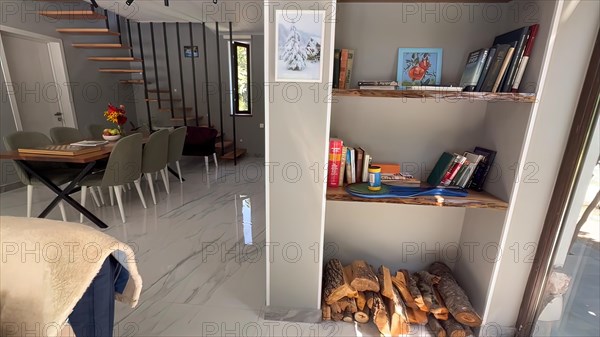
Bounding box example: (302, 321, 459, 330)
(429, 262, 481, 326)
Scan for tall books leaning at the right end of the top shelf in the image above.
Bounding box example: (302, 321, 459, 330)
(460, 24, 539, 92)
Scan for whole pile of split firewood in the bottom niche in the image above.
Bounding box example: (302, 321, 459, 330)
(322, 259, 481, 337)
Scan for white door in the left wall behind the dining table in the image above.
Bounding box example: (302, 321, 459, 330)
(2, 32, 64, 134)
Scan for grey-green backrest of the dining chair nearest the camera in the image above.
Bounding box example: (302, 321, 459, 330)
(102, 133, 142, 187)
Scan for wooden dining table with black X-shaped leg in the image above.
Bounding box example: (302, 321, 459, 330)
(0, 139, 118, 228)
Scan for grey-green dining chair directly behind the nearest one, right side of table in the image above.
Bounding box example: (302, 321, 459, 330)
(140, 129, 170, 205)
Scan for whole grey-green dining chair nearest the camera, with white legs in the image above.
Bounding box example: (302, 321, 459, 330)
(79, 134, 146, 223)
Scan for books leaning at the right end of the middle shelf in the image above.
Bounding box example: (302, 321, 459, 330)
(427, 147, 496, 191)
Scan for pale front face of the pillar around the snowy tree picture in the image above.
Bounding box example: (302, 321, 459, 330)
(265, 1, 335, 310)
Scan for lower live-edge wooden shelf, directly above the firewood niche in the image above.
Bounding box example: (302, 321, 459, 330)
(326, 187, 508, 210)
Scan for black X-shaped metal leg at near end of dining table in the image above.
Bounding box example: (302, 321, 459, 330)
(15, 160, 108, 228)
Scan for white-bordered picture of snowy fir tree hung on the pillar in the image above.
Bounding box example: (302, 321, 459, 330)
(275, 9, 325, 82)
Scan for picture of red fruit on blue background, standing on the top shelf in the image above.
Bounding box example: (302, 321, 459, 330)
(396, 48, 442, 89)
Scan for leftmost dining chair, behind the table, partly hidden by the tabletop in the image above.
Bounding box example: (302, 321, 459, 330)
(4, 131, 78, 221)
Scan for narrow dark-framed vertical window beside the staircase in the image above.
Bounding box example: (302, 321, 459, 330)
(232, 41, 252, 116)
